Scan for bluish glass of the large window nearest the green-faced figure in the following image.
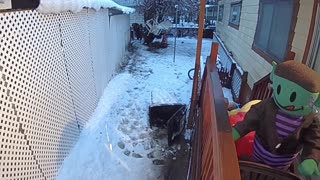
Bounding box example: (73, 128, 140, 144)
(252, 0, 294, 62)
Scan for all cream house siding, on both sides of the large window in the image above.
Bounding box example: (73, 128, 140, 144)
(217, 0, 313, 88)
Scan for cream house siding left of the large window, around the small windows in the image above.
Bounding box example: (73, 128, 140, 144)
(217, 0, 272, 88)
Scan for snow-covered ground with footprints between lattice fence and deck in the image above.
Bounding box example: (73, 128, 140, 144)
(57, 38, 211, 180)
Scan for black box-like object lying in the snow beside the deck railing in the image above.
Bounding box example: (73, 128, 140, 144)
(149, 104, 187, 146)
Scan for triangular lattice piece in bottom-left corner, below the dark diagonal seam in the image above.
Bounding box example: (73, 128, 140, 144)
(0, 86, 43, 179)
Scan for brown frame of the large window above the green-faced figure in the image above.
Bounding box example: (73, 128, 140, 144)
(251, 0, 300, 64)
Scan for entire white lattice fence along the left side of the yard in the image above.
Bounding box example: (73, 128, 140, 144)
(0, 9, 129, 180)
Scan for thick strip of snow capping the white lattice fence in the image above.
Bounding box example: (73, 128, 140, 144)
(37, 0, 135, 14)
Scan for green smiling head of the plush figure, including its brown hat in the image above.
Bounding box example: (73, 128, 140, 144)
(270, 61, 320, 116)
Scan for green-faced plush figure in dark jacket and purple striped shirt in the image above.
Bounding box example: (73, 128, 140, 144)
(232, 61, 320, 176)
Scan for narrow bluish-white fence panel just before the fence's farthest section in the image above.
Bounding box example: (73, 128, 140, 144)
(88, 9, 113, 97)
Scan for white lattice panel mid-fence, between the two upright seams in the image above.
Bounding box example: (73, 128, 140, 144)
(61, 10, 98, 129)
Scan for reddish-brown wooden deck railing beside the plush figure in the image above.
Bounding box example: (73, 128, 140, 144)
(189, 43, 240, 180)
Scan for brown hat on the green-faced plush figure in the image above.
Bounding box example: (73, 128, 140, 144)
(275, 60, 320, 93)
